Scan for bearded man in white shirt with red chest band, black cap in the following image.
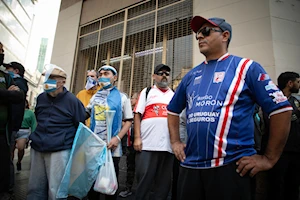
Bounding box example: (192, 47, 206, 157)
(134, 64, 174, 200)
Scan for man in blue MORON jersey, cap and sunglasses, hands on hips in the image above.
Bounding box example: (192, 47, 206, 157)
(168, 16, 292, 200)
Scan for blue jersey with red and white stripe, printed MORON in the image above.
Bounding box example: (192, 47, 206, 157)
(167, 53, 292, 168)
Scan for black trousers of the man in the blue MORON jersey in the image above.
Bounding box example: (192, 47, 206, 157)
(177, 162, 252, 200)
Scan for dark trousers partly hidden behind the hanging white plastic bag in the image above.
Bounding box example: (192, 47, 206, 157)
(88, 157, 120, 200)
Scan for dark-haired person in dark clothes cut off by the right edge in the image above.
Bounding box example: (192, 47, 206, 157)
(263, 72, 300, 200)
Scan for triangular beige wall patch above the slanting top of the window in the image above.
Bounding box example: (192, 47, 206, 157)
(80, 0, 141, 24)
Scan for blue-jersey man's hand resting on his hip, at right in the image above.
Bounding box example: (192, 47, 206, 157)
(236, 154, 276, 177)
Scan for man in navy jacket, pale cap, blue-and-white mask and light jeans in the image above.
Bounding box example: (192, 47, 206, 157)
(27, 65, 85, 200)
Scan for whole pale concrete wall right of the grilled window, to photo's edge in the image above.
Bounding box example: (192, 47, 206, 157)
(193, 0, 300, 82)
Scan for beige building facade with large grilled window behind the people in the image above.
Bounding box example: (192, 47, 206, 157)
(51, 0, 300, 95)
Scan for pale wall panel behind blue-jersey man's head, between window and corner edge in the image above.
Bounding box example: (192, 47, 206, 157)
(193, 0, 275, 77)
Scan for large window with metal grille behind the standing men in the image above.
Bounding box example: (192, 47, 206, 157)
(73, 0, 194, 95)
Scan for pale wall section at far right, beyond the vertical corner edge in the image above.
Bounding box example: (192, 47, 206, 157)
(270, 0, 300, 77)
